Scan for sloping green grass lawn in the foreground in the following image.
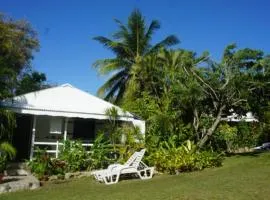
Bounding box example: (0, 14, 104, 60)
(0, 153, 270, 200)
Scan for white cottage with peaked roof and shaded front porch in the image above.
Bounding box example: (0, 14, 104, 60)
(1, 84, 145, 159)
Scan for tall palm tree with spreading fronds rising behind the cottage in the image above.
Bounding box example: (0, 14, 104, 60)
(93, 9, 179, 103)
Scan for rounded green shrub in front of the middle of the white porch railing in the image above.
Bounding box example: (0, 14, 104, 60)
(59, 140, 90, 172)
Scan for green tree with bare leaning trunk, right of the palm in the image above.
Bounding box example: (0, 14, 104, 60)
(189, 44, 268, 147)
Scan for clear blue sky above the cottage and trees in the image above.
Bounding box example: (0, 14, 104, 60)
(0, 0, 270, 94)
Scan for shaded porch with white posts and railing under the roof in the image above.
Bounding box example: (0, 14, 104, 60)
(13, 114, 108, 160)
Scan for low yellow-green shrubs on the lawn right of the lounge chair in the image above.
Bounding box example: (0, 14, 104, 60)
(148, 137, 223, 174)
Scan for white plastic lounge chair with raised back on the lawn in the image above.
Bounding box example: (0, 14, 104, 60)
(93, 149, 154, 185)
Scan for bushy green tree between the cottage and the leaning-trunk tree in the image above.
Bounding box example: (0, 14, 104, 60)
(123, 49, 200, 142)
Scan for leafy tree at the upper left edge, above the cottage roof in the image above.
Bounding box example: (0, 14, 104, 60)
(0, 14, 39, 100)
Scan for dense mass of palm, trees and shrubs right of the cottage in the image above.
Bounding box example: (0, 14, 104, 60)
(94, 10, 270, 173)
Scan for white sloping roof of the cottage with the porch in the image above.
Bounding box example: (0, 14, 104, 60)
(1, 84, 136, 121)
